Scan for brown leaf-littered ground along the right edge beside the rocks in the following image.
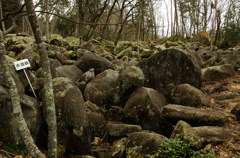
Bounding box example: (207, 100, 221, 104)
(202, 71, 240, 158)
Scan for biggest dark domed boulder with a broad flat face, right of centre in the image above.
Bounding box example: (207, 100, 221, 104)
(139, 49, 201, 95)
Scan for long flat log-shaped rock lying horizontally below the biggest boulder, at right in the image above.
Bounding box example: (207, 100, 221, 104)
(162, 104, 227, 125)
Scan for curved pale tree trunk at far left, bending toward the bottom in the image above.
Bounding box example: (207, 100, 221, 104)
(0, 30, 46, 158)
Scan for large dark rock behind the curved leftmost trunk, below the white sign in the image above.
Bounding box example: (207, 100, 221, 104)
(0, 86, 43, 144)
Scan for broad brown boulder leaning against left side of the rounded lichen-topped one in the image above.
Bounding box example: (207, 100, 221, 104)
(84, 69, 119, 106)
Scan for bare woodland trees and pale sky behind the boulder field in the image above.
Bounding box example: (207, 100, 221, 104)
(1, 0, 240, 47)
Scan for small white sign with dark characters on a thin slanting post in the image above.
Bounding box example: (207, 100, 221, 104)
(13, 59, 37, 98)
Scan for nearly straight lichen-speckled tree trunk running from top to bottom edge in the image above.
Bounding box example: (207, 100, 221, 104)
(25, 0, 57, 158)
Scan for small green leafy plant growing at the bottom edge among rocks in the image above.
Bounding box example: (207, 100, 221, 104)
(146, 138, 215, 158)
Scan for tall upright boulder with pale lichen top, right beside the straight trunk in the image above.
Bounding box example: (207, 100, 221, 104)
(53, 77, 91, 154)
